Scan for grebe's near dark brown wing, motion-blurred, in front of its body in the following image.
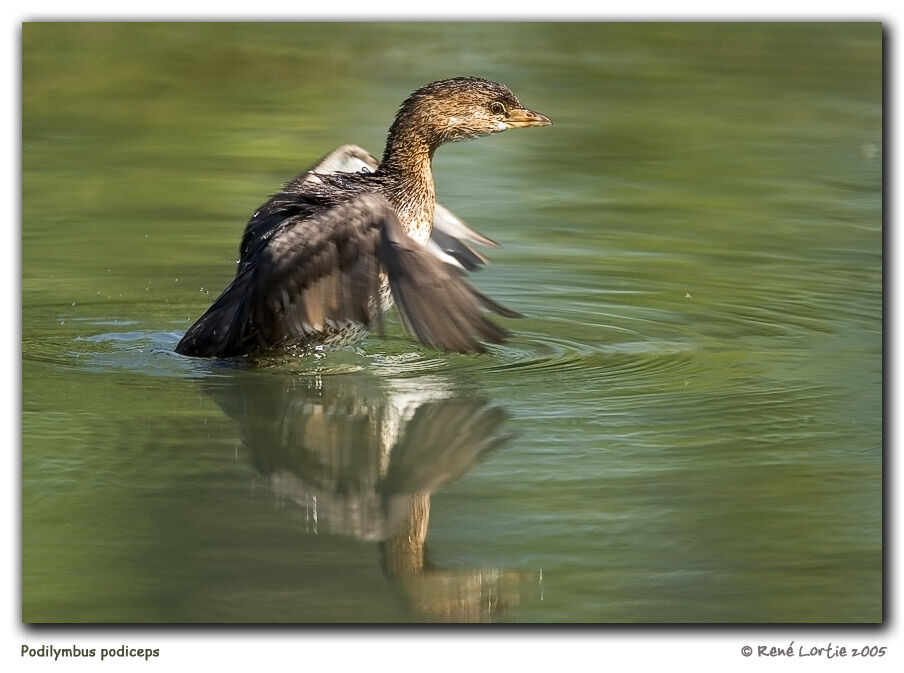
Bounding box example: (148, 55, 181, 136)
(176, 194, 518, 358)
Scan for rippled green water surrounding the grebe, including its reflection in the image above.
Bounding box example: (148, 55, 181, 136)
(22, 23, 882, 622)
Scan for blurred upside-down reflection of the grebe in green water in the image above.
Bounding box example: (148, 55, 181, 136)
(209, 373, 536, 622)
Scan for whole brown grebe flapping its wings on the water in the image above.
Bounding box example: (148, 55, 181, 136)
(176, 77, 551, 358)
